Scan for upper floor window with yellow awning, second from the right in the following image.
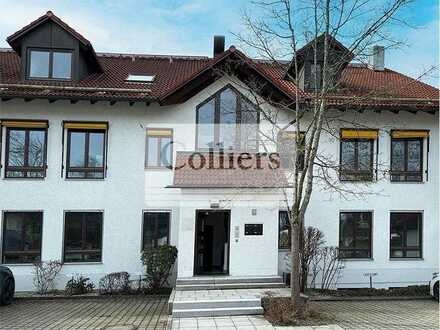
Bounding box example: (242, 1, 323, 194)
(339, 129, 378, 181)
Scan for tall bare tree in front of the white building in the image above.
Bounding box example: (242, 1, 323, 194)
(230, 0, 420, 310)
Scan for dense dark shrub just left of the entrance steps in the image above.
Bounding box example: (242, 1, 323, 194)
(141, 245, 177, 292)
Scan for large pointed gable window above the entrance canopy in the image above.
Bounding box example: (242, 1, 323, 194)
(197, 86, 259, 151)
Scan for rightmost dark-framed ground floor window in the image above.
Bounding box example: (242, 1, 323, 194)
(390, 212, 422, 258)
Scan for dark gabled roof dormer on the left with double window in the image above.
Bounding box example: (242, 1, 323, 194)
(6, 11, 102, 81)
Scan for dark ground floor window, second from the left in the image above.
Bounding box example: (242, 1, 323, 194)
(64, 212, 103, 262)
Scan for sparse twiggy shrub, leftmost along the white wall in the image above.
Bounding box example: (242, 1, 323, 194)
(32, 260, 63, 294)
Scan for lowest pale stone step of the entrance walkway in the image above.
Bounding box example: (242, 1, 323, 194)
(173, 307, 264, 318)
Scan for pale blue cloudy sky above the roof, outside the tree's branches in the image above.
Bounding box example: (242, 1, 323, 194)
(0, 0, 439, 86)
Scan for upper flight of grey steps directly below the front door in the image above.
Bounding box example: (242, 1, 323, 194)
(176, 276, 285, 291)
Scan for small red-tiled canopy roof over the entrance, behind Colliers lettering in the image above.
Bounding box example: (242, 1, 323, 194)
(171, 152, 288, 188)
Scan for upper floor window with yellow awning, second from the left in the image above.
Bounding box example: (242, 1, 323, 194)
(64, 122, 107, 179)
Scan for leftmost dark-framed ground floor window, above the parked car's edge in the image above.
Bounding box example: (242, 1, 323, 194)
(2, 212, 43, 264)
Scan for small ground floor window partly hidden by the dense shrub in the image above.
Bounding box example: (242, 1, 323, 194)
(142, 212, 170, 249)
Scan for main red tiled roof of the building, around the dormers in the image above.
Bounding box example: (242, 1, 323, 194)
(0, 28, 439, 109)
